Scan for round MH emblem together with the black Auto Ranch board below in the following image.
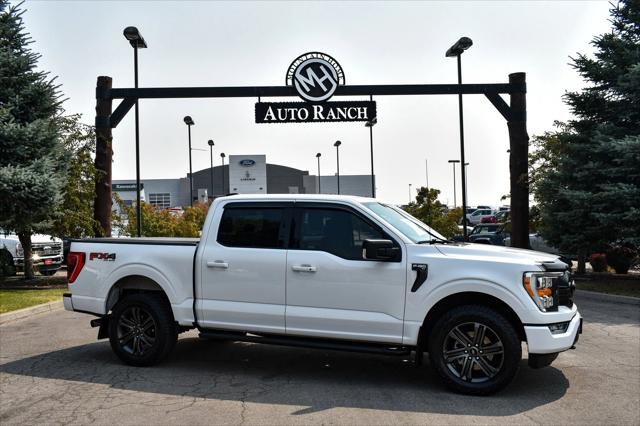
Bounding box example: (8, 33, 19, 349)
(255, 52, 377, 123)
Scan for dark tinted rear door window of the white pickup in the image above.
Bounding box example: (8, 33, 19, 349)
(218, 207, 284, 248)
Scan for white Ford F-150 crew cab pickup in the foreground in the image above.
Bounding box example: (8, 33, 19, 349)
(64, 194, 582, 394)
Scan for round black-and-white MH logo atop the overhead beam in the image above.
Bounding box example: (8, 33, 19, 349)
(287, 52, 344, 102)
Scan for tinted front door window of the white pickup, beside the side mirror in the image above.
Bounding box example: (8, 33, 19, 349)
(297, 208, 388, 260)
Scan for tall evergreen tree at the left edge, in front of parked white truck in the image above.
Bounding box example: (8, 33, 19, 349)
(0, 0, 66, 278)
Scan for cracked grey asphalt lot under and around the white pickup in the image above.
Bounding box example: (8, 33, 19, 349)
(0, 298, 640, 425)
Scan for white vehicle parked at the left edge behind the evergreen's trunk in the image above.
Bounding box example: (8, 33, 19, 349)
(0, 231, 62, 275)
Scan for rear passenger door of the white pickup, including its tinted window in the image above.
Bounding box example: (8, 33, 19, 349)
(198, 202, 293, 333)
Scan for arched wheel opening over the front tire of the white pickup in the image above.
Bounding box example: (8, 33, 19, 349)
(418, 291, 527, 347)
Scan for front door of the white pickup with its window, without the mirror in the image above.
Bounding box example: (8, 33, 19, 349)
(286, 203, 407, 343)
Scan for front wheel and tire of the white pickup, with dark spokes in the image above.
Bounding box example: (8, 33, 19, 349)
(428, 305, 522, 395)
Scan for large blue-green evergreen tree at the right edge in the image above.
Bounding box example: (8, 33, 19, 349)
(531, 0, 640, 272)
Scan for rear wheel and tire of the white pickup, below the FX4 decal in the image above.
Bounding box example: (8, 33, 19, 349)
(109, 293, 178, 367)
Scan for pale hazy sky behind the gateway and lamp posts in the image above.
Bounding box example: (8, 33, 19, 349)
(23, 1, 609, 205)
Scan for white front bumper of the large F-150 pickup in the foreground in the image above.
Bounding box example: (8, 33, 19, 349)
(524, 311, 582, 354)
